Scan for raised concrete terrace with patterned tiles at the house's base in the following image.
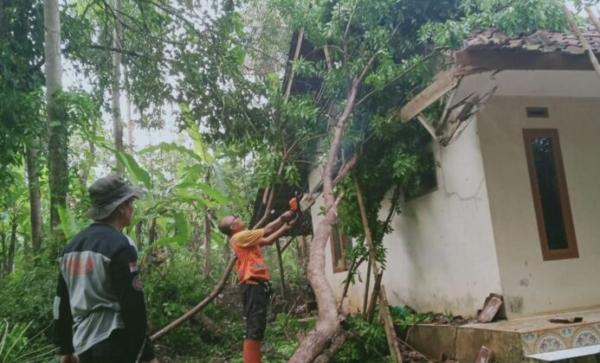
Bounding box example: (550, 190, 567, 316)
(407, 306, 600, 363)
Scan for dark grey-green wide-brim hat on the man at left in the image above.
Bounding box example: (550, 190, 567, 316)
(88, 175, 144, 220)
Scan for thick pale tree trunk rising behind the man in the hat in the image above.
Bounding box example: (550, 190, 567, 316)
(44, 0, 69, 240)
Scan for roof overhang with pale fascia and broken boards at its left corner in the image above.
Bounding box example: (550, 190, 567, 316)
(399, 39, 600, 145)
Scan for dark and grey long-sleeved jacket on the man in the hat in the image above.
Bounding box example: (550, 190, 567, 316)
(54, 223, 154, 361)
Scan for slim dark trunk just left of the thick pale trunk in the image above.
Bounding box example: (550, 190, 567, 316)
(25, 137, 43, 254)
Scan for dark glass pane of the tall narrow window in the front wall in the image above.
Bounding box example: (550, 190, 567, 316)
(530, 136, 569, 250)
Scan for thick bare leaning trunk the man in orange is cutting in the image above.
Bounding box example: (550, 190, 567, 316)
(289, 77, 364, 363)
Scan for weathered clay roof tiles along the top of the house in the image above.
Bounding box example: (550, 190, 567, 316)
(463, 30, 600, 55)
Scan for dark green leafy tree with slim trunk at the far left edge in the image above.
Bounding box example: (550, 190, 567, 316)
(0, 0, 45, 251)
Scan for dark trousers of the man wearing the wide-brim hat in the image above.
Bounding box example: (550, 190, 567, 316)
(79, 329, 136, 363)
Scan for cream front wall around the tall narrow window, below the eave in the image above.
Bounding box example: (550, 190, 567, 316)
(478, 95, 600, 317)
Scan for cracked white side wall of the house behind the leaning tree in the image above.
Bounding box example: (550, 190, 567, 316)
(310, 122, 502, 316)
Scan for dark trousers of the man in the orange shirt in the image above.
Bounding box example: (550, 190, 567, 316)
(241, 282, 271, 340)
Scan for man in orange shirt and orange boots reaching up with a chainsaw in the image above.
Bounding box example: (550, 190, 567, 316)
(219, 211, 295, 363)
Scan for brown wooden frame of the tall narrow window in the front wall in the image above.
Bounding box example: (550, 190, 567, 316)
(523, 129, 579, 261)
